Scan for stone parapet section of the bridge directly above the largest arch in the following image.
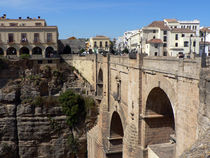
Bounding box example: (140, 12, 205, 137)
(142, 56, 201, 80)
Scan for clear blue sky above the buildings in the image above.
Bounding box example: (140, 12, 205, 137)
(0, 0, 210, 39)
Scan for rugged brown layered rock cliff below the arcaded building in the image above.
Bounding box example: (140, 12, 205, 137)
(0, 58, 96, 158)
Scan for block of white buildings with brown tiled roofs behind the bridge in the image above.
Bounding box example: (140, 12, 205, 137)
(124, 19, 200, 56)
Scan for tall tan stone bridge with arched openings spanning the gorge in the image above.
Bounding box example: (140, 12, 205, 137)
(63, 54, 210, 158)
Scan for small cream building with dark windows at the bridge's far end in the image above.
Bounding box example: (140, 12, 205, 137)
(89, 36, 110, 53)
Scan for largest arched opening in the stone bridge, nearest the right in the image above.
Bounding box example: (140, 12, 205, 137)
(145, 87, 175, 146)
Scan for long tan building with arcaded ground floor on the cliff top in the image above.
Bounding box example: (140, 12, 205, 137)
(0, 15, 58, 58)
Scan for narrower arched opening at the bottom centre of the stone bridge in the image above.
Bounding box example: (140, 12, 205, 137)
(107, 112, 124, 158)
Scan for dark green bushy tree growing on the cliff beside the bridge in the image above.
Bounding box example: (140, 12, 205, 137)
(58, 90, 86, 156)
